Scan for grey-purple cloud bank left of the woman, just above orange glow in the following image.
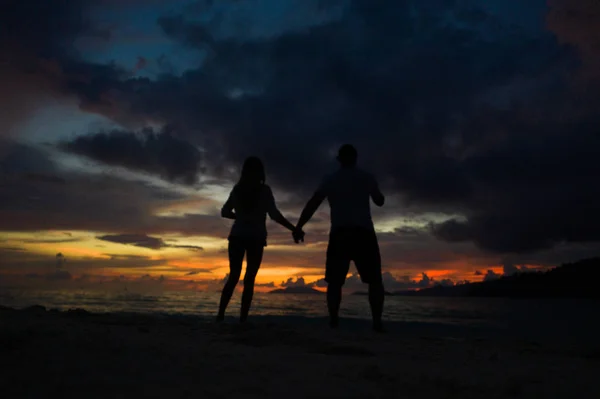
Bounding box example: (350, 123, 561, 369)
(0, 142, 227, 241)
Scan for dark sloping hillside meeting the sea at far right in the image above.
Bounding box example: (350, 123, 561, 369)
(382, 257, 600, 298)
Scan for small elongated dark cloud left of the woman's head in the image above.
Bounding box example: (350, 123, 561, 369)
(61, 129, 201, 184)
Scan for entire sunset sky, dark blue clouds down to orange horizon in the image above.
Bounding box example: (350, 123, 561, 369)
(0, 0, 600, 290)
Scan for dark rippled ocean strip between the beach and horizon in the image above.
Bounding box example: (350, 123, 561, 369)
(0, 290, 600, 337)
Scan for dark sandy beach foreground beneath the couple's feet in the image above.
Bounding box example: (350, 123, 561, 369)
(0, 307, 600, 399)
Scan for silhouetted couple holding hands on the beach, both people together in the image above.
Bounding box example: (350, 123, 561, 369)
(217, 144, 385, 331)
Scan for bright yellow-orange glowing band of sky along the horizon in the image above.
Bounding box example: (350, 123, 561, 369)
(0, 230, 536, 291)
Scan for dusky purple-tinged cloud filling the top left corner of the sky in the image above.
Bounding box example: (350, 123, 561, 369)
(0, 0, 108, 135)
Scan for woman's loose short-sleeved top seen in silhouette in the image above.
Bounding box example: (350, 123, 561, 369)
(221, 184, 280, 245)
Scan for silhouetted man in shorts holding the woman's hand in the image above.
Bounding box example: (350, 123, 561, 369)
(296, 144, 385, 331)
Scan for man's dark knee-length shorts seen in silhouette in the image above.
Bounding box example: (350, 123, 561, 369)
(325, 227, 381, 285)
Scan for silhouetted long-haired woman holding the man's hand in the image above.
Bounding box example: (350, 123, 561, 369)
(217, 157, 304, 322)
